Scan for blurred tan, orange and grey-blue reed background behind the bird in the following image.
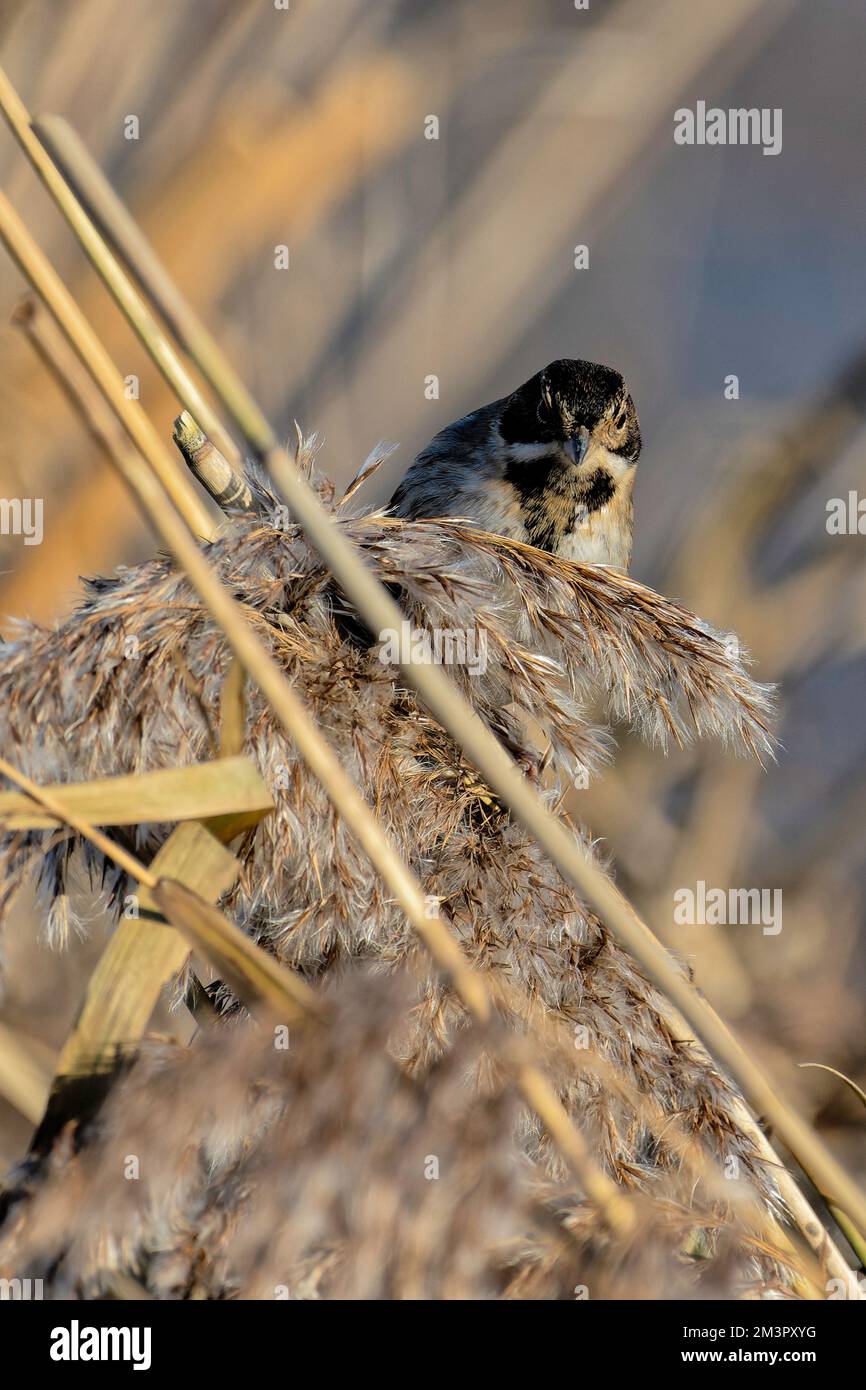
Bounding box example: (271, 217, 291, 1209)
(0, 0, 866, 1173)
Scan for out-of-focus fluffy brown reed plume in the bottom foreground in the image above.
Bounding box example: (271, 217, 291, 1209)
(0, 974, 795, 1298)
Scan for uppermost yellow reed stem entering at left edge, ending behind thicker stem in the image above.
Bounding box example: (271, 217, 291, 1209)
(0, 67, 236, 483)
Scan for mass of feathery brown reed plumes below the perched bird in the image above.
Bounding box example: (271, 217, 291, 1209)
(0, 456, 795, 1297)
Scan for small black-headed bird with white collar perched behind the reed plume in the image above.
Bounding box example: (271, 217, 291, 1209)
(389, 357, 641, 570)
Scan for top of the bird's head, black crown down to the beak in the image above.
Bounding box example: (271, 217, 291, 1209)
(499, 357, 641, 463)
